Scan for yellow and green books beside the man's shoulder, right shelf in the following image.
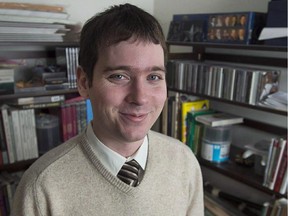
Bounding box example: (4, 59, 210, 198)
(162, 93, 243, 151)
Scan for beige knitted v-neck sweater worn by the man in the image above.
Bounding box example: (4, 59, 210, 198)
(12, 131, 204, 216)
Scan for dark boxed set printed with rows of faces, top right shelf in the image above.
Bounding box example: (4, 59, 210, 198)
(167, 12, 266, 44)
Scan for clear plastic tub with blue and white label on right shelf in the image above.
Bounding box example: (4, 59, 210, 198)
(201, 125, 231, 163)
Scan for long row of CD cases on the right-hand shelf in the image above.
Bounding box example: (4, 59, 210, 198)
(167, 60, 280, 105)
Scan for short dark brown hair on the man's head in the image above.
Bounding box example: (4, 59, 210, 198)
(79, 4, 167, 85)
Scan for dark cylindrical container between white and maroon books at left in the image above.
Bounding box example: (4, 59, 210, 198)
(36, 114, 60, 154)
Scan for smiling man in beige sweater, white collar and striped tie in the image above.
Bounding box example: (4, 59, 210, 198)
(12, 4, 204, 216)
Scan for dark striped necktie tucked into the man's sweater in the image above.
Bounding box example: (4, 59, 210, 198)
(117, 159, 144, 187)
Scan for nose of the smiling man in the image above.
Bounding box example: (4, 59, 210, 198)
(126, 80, 151, 106)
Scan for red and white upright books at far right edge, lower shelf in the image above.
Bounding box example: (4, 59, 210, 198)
(263, 138, 288, 194)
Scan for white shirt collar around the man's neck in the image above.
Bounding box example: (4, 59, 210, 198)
(86, 123, 148, 176)
